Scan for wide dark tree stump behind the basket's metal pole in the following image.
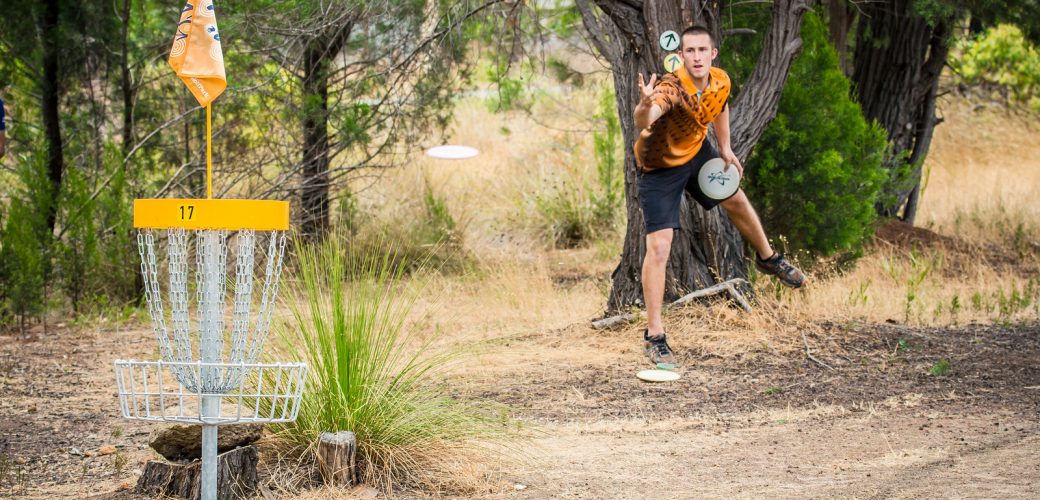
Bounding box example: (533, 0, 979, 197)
(134, 446, 259, 500)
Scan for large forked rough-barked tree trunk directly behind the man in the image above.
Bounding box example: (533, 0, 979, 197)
(576, 0, 810, 312)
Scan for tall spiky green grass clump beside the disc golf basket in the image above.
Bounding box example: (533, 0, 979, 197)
(268, 236, 511, 491)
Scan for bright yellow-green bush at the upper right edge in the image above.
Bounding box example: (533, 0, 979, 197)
(950, 24, 1040, 111)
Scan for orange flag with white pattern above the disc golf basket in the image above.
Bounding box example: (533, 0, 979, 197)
(170, 0, 228, 106)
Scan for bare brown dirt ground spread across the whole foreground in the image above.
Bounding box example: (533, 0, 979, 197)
(0, 307, 1040, 498)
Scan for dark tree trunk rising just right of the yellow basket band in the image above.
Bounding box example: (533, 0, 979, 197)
(301, 24, 350, 239)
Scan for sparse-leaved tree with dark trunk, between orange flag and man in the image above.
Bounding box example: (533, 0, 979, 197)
(229, 0, 514, 237)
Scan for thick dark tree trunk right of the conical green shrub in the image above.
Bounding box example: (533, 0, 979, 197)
(853, 0, 951, 223)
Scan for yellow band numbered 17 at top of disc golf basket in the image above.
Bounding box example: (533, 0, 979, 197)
(133, 199, 289, 231)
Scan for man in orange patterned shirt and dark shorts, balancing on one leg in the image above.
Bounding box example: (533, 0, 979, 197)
(635, 26, 805, 364)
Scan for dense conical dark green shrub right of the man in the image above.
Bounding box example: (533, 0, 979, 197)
(744, 12, 888, 257)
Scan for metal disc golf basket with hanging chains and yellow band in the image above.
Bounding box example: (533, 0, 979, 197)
(115, 200, 307, 499)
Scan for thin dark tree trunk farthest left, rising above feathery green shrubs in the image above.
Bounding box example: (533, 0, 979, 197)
(41, 0, 64, 231)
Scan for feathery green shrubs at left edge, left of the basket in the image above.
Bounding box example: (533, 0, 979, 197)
(0, 136, 139, 324)
